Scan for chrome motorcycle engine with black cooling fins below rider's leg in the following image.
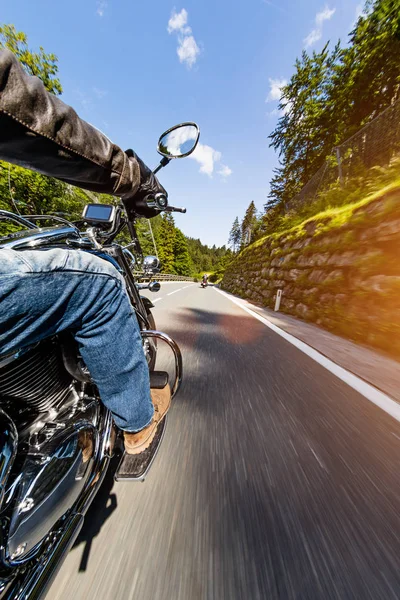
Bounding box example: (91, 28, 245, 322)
(0, 338, 101, 567)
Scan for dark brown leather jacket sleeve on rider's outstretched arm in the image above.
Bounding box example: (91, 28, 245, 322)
(0, 50, 140, 199)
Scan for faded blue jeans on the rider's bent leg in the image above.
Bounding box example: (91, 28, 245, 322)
(0, 248, 154, 431)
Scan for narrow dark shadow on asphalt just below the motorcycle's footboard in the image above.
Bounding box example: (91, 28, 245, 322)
(73, 457, 120, 571)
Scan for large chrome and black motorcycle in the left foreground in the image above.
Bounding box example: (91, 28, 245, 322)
(0, 123, 200, 600)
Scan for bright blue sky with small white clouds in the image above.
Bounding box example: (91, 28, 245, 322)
(0, 0, 362, 245)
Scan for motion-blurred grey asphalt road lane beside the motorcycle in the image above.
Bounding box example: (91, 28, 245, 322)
(48, 283, 400, 600)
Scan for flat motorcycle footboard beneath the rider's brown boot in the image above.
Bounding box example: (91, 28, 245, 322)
(114, 418, 167, 481)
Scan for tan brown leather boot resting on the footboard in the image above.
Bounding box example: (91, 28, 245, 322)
(124, 385, 171, 454)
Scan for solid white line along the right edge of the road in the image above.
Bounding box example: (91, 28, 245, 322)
(213, 288, 400, 421)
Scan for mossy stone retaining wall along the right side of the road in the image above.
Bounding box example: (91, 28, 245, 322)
(221, 191, 400, 358)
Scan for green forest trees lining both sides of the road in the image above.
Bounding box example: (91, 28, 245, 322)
(0, 0, 400, 275)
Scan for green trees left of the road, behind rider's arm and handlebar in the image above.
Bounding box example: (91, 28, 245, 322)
(0, 25, 227, 275)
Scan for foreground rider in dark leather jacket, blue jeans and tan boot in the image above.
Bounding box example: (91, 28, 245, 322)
(0, 50, 171, 454)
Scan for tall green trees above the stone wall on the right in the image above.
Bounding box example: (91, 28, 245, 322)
(264, 0, 400, 217)
